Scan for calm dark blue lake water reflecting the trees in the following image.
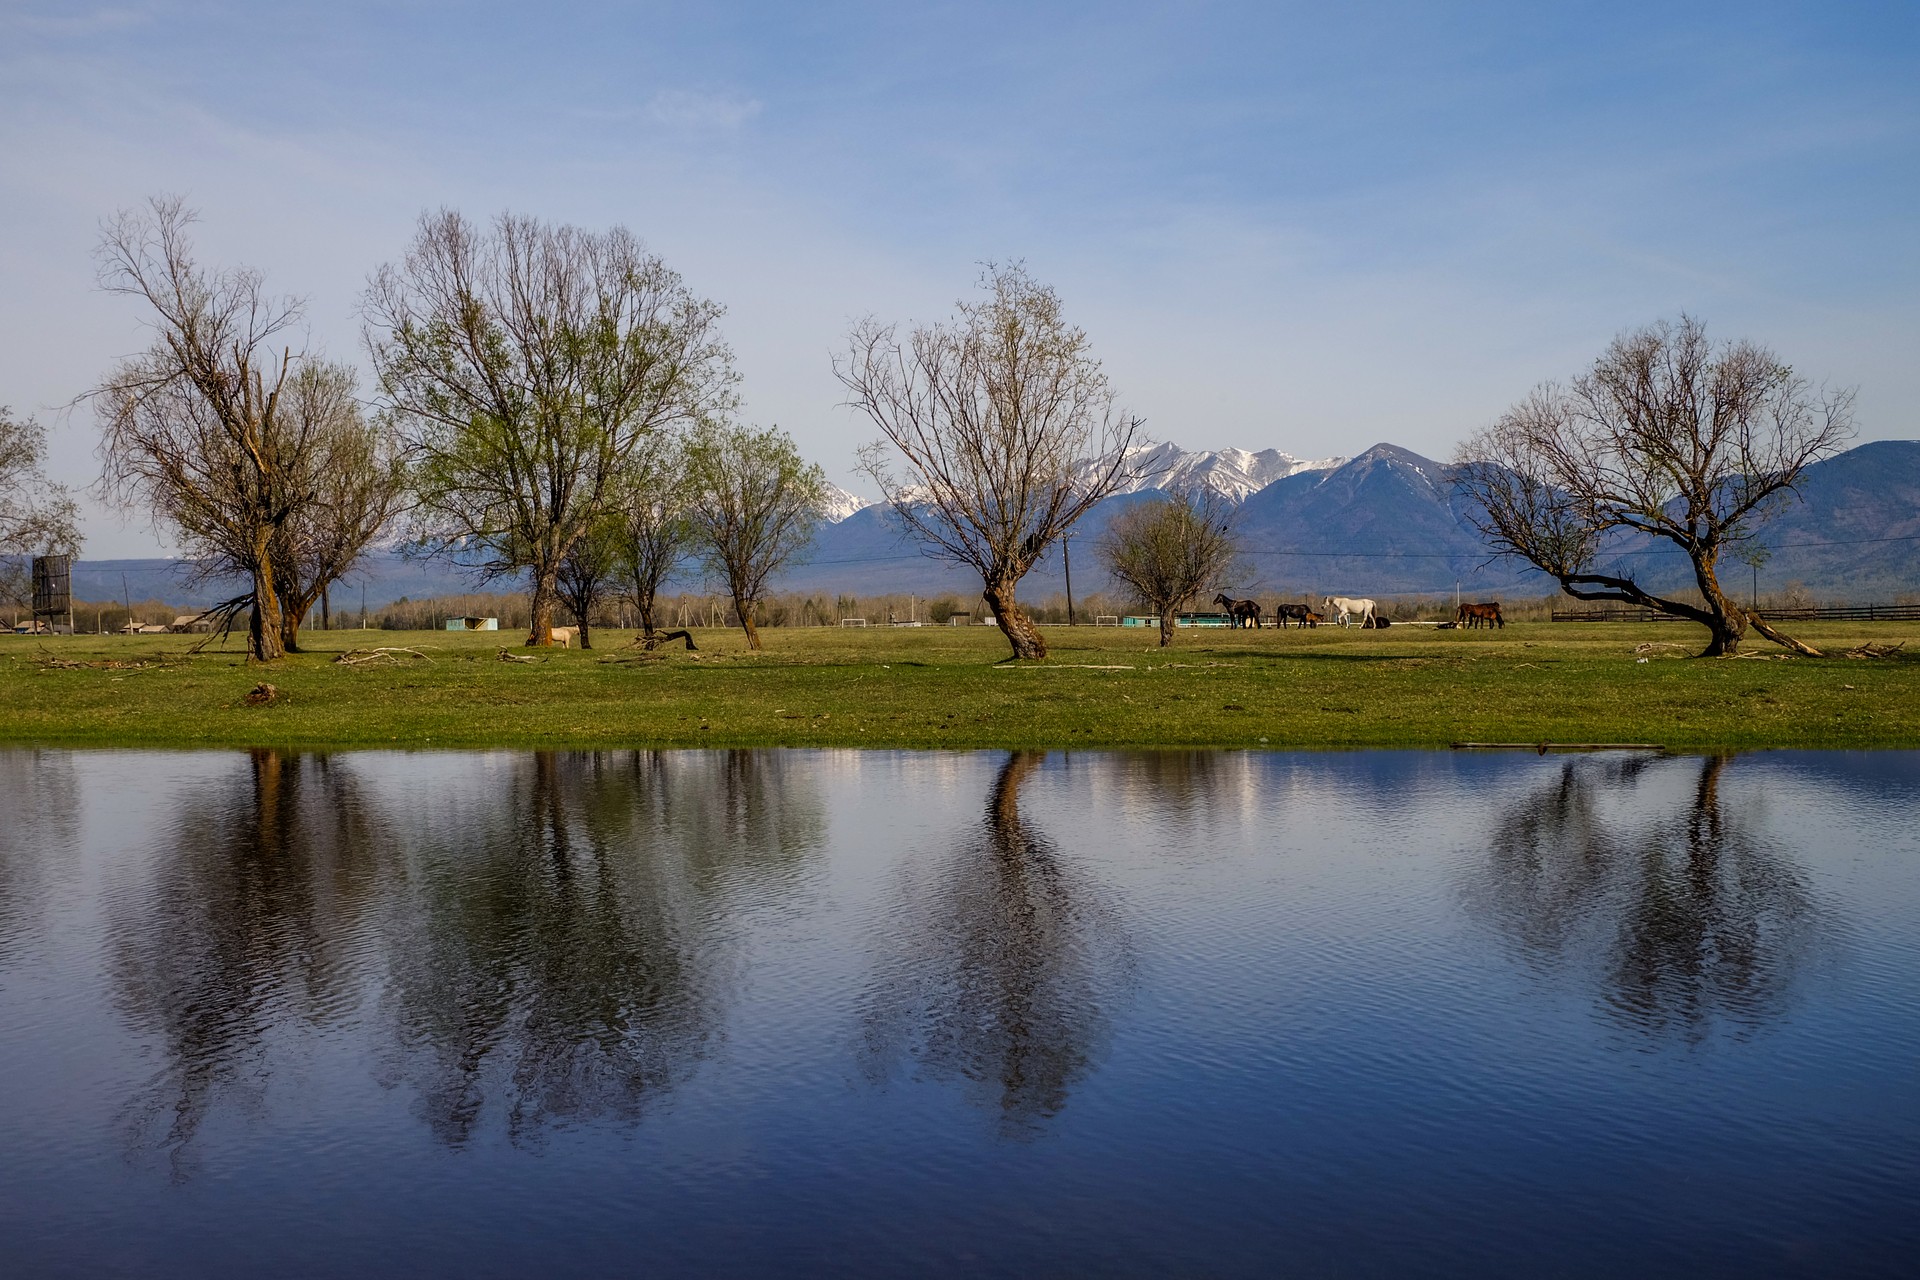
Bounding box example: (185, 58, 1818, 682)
(0, 752, 1920, 1276)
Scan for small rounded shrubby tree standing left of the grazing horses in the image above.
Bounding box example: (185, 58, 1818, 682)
(1100, 486, 1238, 647)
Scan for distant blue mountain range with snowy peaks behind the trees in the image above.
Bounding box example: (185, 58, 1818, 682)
(41, 439, 1920, 608)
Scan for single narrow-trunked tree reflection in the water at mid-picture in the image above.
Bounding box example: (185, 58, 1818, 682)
(862, 752, 1133, 1138)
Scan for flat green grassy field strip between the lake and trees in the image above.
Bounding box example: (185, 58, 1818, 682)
(0, 624, 1920, 748)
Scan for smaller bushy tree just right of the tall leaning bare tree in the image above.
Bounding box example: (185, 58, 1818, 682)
(273, 361, 407, 652)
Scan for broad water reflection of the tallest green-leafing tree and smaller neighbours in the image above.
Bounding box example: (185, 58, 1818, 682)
(378, 750, 824, 1144)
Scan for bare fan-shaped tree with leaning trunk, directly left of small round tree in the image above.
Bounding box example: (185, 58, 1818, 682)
(833, 265, 1140, 658)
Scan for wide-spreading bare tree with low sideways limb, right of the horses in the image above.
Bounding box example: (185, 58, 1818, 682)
(1461, 317, 1853, 656)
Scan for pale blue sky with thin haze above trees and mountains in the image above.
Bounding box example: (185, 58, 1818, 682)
(0, 0, 1920, 557)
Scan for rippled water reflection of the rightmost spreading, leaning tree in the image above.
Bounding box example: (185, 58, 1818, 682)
(1469, 756, 1824, 1040)
